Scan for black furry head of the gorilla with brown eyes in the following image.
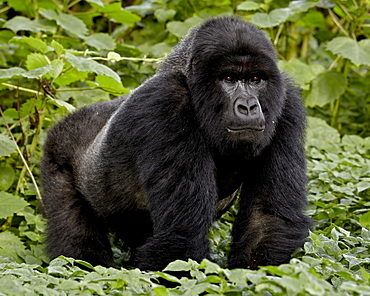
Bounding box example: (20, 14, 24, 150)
(162, 18, 286, 154)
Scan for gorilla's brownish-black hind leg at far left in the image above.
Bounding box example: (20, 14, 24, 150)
(44, 169, 113, 266)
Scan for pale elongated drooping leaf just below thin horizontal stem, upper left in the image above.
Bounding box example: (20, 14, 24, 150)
(65, 53, 121, 82)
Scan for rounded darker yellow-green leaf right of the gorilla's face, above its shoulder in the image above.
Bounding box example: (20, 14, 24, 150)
(306, 71, 347, 107)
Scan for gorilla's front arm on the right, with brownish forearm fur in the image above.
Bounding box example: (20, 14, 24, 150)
(229, 84, 311, 269)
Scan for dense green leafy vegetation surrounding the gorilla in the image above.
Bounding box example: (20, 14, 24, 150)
(0, 0, 370, 295)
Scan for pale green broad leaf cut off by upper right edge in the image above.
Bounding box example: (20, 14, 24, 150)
(326, 37, 370, 66)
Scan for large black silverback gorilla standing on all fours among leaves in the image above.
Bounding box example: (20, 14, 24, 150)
(42, 17, 311, 270)
